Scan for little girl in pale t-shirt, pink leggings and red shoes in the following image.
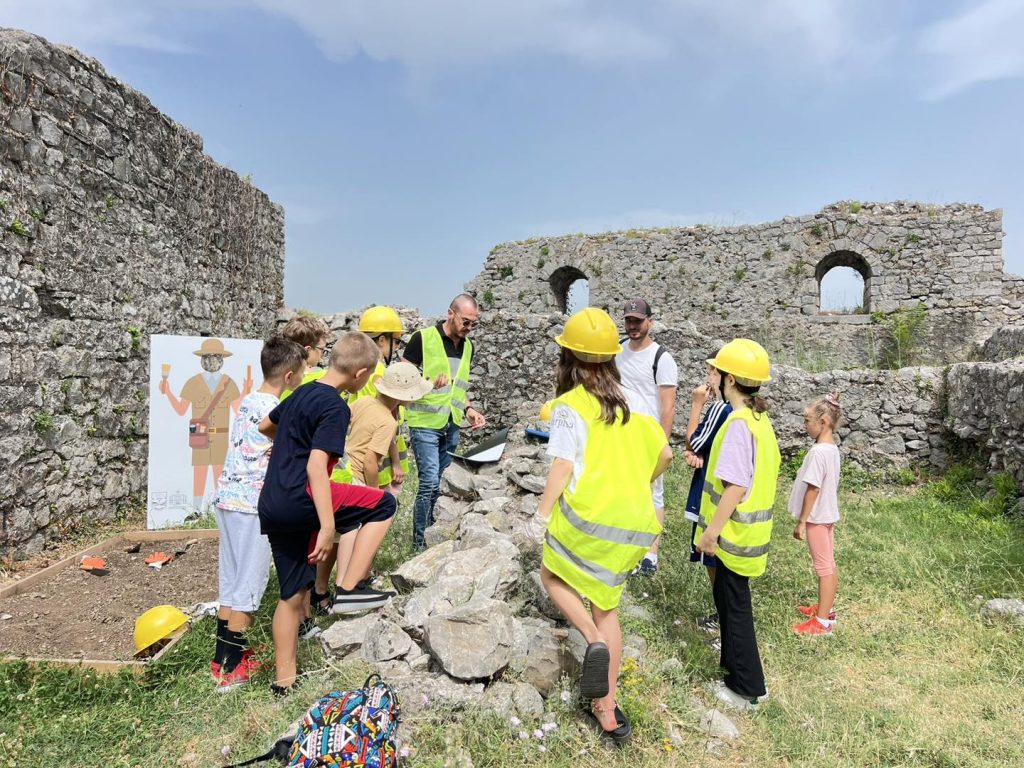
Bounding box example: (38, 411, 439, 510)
(790, 392, 843, 635)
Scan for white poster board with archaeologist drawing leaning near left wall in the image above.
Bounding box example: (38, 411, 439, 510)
(145, 336, 263, 528)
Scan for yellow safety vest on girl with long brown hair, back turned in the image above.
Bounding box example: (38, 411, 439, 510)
(544, 386, 666, 610)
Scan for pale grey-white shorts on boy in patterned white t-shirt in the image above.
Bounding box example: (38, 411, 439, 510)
(214, 506, 270, 613)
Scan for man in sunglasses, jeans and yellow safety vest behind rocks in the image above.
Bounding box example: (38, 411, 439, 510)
(403, 293, 487, 550)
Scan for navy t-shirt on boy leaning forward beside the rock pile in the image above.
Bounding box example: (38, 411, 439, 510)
(258, 381, 350, 534)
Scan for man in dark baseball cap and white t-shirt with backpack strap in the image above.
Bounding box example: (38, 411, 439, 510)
(615, 297, 679, 575)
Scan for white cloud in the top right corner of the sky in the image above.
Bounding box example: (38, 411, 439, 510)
(919, 0, 1024, 98)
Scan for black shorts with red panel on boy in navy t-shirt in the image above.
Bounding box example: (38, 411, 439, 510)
(267, 483, 396, 600)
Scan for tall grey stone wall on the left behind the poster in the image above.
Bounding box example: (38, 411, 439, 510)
(0, 30, 284, 556)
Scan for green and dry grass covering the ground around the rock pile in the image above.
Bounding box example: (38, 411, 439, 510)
(0, 468, 1024, 768)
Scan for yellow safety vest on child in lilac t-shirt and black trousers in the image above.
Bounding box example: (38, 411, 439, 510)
(693, 408, 782, 578)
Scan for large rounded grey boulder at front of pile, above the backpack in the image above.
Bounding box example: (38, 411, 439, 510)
(423, 599, 512, 680)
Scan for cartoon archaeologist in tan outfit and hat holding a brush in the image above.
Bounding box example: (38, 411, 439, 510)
(160, 339, 253, 510)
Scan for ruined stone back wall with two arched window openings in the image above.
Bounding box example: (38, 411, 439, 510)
(467, 203, 1011, 370)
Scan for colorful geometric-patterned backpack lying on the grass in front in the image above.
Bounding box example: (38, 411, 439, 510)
(229, 675, 401, 768)
